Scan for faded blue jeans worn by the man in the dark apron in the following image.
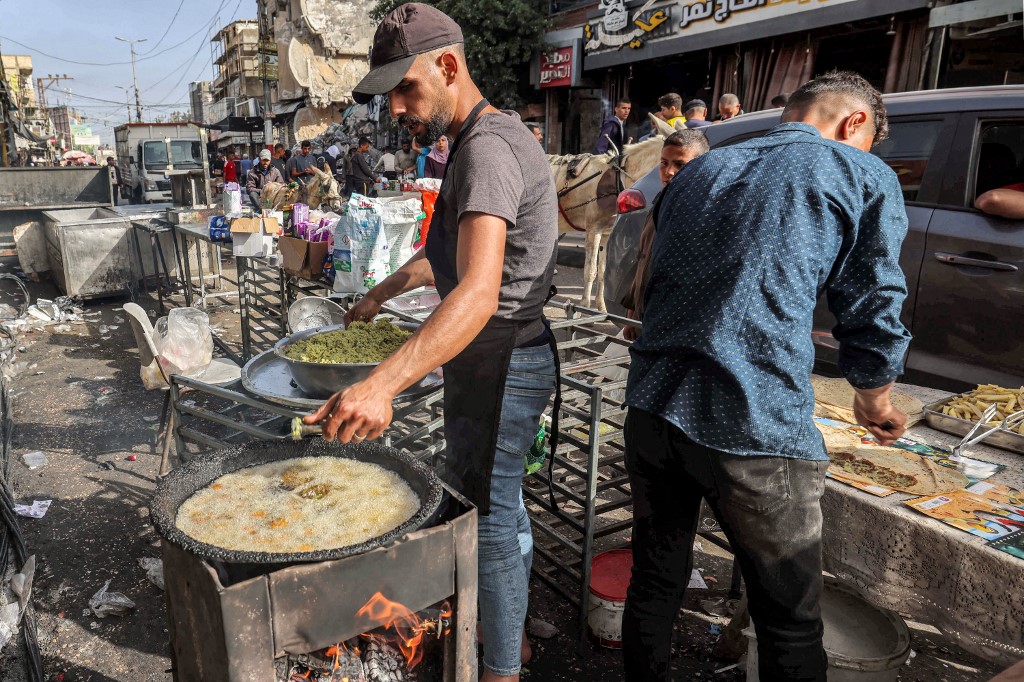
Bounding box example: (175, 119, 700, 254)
(478, 345, 557, 676)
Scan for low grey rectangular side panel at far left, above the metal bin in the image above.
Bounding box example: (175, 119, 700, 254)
(0, 166, 111, 211)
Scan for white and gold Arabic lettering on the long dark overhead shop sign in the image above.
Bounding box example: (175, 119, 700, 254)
(584, 0, 855, 53)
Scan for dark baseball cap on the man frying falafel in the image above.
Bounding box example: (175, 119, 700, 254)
(352, 2, 463, 104)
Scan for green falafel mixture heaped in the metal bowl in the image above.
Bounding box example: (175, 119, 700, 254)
(285, 319, 413, 365)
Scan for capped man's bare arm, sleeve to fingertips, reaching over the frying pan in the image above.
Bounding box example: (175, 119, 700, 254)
(305, 213, 506, 442)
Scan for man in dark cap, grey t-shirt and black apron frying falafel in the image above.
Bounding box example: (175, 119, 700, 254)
(306, 3, 558, 682)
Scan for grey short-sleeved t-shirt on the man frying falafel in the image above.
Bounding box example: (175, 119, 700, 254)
(441, 112, 558, 322)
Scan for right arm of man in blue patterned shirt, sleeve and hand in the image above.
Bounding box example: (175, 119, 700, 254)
(826, 173, 910, 444)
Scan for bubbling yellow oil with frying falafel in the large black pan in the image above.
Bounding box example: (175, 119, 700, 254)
(175, 457, 420, 554)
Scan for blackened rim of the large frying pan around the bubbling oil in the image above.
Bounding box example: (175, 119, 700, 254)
(150, 438, 444, 565)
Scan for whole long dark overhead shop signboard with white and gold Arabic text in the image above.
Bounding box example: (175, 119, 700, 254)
(584, 0, 930, 71)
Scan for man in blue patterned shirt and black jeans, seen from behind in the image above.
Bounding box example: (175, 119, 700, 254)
(623, 72, 910, 682)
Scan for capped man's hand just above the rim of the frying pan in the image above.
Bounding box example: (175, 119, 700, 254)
(302, 378, 394, 442)
